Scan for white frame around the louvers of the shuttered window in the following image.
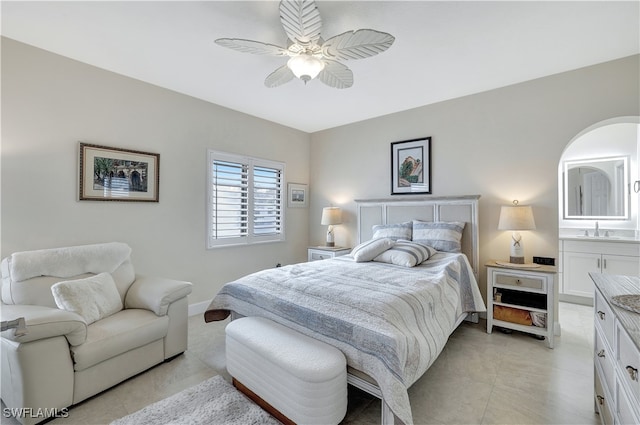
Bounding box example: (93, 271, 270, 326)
(206, 149, 287, 249)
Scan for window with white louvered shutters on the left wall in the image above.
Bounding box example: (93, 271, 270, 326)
(207, 150, 284, 248)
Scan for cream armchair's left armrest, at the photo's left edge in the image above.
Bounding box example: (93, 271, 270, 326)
(0, 304, 87, 346)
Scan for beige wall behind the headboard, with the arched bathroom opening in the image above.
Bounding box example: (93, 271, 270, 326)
(310, 56, 640, 298)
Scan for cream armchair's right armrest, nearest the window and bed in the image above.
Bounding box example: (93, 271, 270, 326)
(124, 275, 191, 316)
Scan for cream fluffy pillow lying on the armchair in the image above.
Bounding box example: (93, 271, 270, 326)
(51, 273, 122, 325)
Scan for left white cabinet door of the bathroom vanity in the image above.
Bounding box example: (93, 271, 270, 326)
(562, 252, 602, 298)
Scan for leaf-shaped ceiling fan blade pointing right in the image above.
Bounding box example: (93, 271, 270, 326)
(322, 29, 395, 60)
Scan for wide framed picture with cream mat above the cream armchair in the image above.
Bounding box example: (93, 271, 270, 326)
(78, 143, 160, 202)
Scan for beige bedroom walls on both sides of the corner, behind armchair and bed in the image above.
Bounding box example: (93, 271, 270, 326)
(0, 39, 640, 304)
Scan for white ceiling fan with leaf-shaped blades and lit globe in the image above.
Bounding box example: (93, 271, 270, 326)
(215, 0, 395, 89)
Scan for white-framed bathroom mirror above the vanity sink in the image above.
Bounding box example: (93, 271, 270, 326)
(563, 156, 629, 220)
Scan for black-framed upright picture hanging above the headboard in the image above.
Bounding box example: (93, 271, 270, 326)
(391, 137, 431, 195)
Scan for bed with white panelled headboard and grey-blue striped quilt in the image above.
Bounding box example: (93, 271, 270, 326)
(205, 196, 485, 424)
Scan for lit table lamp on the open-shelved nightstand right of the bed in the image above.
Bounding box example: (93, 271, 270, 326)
(496, 200, 536, 267)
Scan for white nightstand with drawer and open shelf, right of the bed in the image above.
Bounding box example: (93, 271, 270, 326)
(485, 260, 557, 348)
